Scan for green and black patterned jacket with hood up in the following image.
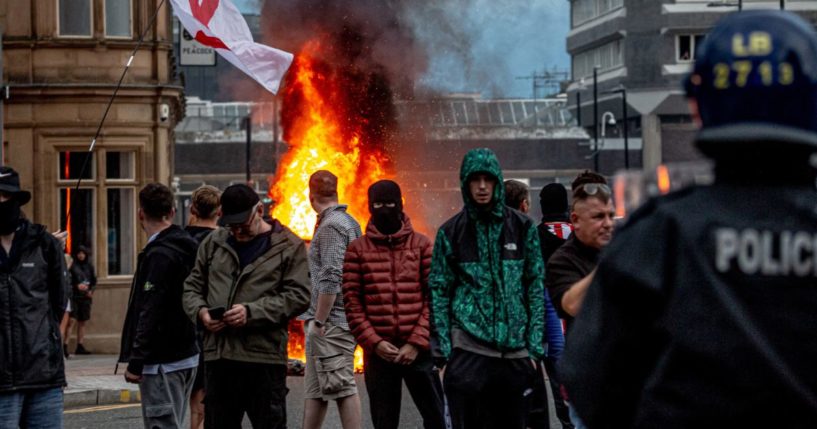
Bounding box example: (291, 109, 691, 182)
(429, 149, 544, 360)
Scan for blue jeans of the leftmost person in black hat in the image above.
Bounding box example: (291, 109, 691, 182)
(0, 387, 62, 429)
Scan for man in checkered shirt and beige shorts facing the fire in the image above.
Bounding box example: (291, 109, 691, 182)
(299, 170, 361, 429)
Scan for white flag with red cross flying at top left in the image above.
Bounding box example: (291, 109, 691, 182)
(170, 0, 293, 94)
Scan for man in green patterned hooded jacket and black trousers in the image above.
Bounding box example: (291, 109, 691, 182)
(429, 149, 545, 429)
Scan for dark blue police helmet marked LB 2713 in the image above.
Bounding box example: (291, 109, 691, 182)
(685, 10, 817, 157)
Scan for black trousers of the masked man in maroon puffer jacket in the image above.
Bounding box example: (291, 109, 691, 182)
(363, 351, 445, 429)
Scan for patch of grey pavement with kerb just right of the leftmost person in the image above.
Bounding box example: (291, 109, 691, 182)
(65, 355, 140, 408)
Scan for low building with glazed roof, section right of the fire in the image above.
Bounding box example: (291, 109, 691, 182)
(391, 94, 600, 227)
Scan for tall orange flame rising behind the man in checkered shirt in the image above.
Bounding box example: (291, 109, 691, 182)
(269, 42, 391, 240)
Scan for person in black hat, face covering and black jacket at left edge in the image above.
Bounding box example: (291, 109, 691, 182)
(0, 167, 71, 428)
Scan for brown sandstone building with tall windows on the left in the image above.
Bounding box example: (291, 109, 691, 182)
(0, 0, 184, 352)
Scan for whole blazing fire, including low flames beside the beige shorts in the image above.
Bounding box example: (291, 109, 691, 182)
(278, 41, 393, 372)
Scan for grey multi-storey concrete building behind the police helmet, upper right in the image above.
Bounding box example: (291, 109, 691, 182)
(567, 0, 817, 174)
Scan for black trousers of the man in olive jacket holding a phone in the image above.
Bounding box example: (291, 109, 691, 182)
(204, 359, 288, 429)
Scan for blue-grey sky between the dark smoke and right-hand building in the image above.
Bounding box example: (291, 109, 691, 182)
(234, 0, 570, 98)
